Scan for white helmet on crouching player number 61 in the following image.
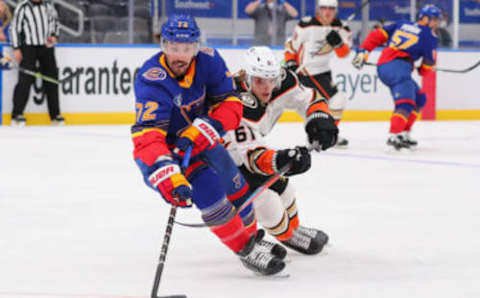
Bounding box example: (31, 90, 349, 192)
(245, 47, 282, 85)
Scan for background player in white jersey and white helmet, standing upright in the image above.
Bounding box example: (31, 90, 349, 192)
(285, 0, 352, 148)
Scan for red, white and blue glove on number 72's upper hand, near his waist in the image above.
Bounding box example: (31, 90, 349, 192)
(174, 117, 223, 157)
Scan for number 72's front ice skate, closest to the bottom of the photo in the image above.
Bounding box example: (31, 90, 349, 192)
(238, 233, 285, 275)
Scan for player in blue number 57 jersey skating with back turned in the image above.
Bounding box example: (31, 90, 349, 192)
(353, 5, 441, 150)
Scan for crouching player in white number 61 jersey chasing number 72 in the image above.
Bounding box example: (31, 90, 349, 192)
(224, 47, 338, 255)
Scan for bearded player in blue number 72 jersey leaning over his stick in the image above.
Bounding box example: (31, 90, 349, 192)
(131, 15, 285, 275)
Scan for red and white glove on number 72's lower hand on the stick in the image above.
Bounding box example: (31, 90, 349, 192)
(148, 162, 192, 207)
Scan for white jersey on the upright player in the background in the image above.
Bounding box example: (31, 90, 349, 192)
(285, 17, 352, 76)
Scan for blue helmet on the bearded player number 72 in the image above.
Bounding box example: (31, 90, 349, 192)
(161, 14, 200, 43)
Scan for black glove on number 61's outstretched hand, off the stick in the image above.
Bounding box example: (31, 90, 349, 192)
(305, 111, 338, 151)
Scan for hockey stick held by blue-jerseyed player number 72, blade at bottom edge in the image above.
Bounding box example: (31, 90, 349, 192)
(151, 146, 192, 298)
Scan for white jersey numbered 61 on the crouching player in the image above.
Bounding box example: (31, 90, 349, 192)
(224, 69, 325, 174)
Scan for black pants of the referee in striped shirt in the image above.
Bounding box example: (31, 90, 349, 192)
(12, 46, 60, 119)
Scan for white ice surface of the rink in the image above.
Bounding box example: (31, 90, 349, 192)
(0, 121, 480, 298)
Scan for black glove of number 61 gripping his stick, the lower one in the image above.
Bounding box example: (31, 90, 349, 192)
(275, 146, 311, 176)
